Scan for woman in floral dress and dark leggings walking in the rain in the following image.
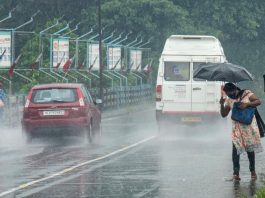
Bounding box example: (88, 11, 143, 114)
(220, 83, 262, 181)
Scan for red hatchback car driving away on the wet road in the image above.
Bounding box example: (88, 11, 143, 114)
(22, 83, 101, 142)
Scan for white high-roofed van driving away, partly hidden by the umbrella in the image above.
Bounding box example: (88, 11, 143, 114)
(156, 35, 226, 124)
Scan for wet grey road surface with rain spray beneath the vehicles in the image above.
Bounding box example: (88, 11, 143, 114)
(0, 104, 265, 198)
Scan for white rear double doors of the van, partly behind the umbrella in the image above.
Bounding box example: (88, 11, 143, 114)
(162, 61, 221, 114)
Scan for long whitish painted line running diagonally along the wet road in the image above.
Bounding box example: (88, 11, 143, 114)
(0, 136, 156, 197)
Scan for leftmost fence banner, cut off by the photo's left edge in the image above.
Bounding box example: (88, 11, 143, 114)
(0, 31, 11, 68)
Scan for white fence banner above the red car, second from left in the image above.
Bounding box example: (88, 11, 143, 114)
(52, 38, 69, 68)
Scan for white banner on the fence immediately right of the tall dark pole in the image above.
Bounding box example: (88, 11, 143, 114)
(108, 47, 121, 70)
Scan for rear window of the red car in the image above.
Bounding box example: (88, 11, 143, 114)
(32, 88, 77, 103)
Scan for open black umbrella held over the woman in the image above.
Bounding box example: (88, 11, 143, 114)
(193, 62, 253, 83)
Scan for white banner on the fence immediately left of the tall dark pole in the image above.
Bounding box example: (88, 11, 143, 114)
(88, 43, 99, 70)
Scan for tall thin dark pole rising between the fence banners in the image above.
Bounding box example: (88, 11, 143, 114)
(98, 0, 104, 108)
